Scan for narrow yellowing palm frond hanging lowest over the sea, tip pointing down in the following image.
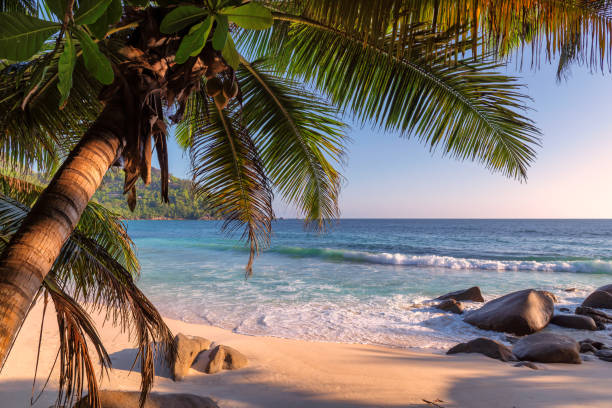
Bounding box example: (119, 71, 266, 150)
(188, 94, 274, 276)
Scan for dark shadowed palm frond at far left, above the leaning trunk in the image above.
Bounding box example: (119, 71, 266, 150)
(0, 52, 101, 171)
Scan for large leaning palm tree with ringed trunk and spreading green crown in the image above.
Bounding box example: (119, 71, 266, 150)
(0, 0, 612, 406)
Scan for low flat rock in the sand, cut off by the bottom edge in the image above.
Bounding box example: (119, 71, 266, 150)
(74, 391, 219, 408)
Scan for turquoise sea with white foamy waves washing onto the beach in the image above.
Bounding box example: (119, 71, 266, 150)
(128, 220, 612, 349)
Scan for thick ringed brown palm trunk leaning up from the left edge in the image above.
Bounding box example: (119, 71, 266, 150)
(0, 98, 127, 370)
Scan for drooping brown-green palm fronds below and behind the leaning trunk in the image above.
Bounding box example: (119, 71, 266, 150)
(0, 171, 175, 406)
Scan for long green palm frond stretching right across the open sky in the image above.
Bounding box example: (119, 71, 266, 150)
(241, 24, 539, 178)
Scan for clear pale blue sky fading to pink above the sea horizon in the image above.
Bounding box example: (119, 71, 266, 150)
(159, 60, 612, 218)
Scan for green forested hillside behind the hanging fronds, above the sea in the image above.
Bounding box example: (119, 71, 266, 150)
(93, 169, 211, 219)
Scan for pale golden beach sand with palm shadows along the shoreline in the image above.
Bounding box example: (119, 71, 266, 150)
(0, 306, 612, 408)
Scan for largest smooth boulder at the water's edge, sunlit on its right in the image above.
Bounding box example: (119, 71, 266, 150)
(464, 289, 554, 336)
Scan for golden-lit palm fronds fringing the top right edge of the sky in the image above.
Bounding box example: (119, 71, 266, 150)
(269, 0, 612, 69)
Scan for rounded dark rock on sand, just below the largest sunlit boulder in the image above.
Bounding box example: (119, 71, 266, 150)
(512, 333, 582, 364)
